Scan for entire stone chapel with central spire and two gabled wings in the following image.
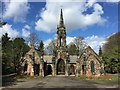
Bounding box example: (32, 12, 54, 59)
(21, 9, 104, 77)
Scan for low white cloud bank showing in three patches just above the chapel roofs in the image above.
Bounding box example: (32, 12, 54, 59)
(44, 35, 106, 53)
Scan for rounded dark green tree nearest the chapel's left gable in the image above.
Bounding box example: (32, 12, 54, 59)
(13, 38, 29, 74)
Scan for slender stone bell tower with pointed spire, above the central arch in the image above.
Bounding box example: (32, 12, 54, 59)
(57, 9, 66, 51)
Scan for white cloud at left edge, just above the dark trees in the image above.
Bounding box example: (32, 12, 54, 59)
(0, 24, 20, 38)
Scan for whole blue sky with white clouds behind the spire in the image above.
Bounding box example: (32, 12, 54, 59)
(0, 0, 118, 52)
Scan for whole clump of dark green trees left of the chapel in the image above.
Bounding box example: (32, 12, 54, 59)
(2, 33, 29, 74)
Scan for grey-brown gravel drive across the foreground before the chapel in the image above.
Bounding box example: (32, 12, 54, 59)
(3, 76, 118, 90)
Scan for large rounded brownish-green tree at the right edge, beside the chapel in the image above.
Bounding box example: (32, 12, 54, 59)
(102, 32, 120, 73)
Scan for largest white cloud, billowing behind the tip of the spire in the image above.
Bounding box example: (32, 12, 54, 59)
(35, 0, 106, 33)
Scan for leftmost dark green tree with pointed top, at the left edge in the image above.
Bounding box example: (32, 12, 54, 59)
(2, 33, 14, 75)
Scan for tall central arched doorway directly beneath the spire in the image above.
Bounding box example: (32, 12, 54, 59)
(57, 59, 65, 75)
